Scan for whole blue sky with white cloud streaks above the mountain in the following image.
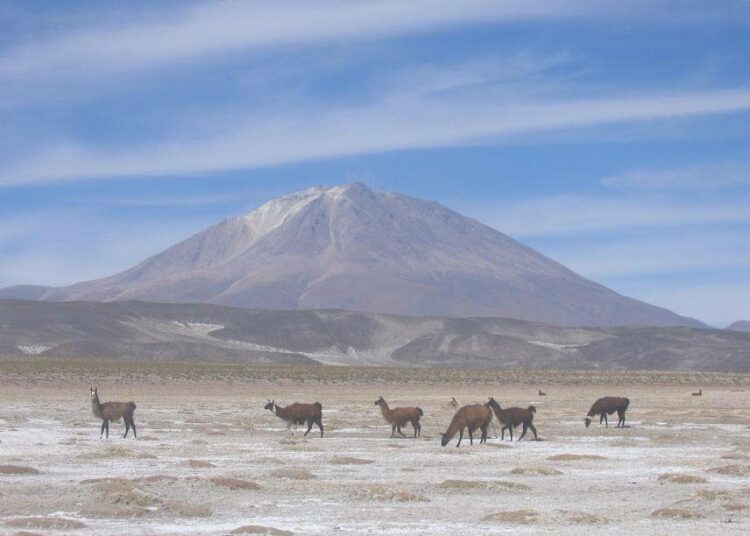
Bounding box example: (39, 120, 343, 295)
(0, 0, 750, 327)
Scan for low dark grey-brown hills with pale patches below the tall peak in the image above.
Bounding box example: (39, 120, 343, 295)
(0, 300, 750, 372)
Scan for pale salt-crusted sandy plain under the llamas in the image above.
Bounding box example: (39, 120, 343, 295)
(0, 360, 750, 535)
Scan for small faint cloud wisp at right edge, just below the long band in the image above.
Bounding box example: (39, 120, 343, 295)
(602, 162, 750, 190)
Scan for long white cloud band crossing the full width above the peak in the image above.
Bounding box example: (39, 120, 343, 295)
(0, 89, 750, 186)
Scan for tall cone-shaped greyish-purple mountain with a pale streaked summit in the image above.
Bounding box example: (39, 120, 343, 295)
(0, 183, 702, 326)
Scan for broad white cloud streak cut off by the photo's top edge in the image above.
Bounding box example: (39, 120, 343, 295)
(0, 0, 596, 84)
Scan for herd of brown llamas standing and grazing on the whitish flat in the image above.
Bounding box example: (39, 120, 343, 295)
(91, 387, 640, 447)
